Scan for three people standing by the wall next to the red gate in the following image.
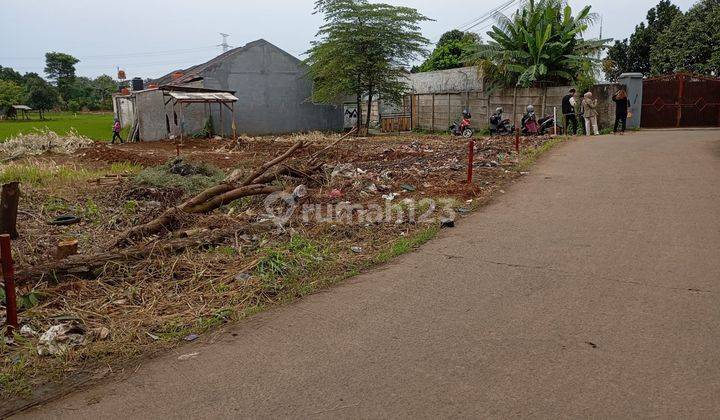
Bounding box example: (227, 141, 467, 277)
(562, 89, 630, 136)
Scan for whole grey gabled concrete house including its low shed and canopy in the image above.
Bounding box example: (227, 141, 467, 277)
(115, 39, 344, 141)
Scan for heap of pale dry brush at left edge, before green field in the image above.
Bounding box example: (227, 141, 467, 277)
(0, 128, 94, 160)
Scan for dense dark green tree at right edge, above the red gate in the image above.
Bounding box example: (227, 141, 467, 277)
(650, 0, 720, 76)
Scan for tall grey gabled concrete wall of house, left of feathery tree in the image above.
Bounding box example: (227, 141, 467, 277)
(201, 42, 344, 134)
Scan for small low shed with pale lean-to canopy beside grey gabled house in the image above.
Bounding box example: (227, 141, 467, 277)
(113, 86, 237, 141)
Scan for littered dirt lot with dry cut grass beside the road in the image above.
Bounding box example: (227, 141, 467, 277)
(0, 134, 552, 410)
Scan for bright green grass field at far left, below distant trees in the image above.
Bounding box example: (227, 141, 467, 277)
(0, 112, 128, 142)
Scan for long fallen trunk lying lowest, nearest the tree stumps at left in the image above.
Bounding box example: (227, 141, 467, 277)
(15, 223, 275, 284)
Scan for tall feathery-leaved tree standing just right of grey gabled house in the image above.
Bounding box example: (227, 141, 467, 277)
(306, 0, 430, 128)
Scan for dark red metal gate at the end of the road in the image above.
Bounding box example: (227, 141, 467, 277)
(640, 73, 720, 128)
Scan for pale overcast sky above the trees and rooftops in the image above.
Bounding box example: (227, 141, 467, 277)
(0, 0, 694, 78)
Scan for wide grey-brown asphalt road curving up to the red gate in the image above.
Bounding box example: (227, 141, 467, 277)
(16, 130, 720, 419)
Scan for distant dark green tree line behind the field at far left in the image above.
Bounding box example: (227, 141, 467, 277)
(0, 52, 118, 118)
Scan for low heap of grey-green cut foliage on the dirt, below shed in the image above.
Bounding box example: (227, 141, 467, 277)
(135, 159, 225, 194)
